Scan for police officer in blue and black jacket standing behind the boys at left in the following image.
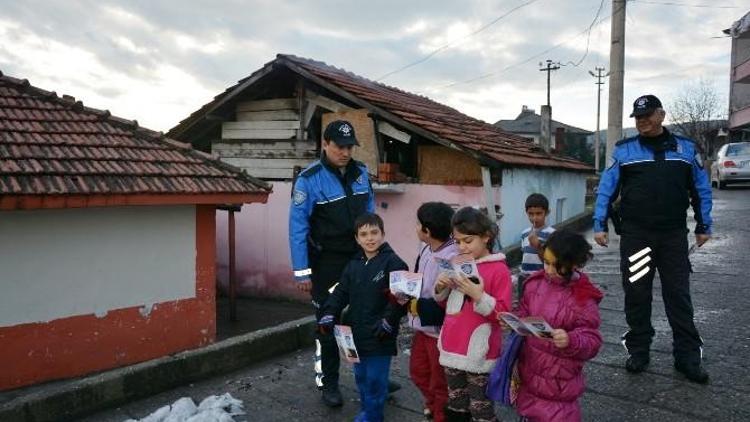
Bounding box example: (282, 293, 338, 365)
(289, 120, 375, 407)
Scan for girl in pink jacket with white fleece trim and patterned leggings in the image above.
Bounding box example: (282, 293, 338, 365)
(435, 207, 511, 422)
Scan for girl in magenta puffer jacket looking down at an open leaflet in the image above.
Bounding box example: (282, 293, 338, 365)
(515, 230, 602, 422)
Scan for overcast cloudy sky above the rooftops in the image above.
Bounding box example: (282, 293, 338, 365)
(0, 0, 750, 131)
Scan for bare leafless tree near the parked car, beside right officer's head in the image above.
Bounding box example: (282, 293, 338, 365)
(667, 78, 726, 156)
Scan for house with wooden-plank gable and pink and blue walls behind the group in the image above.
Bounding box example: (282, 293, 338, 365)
(168, 55, 593, 296)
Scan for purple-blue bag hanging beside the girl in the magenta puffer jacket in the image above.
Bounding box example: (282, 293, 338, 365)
(487, 331, 523, 406)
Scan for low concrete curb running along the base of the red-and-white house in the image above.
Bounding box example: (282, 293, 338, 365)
(0, 316, 315, 422)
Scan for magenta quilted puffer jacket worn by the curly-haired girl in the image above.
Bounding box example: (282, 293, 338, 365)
(516, 270, 602, 422)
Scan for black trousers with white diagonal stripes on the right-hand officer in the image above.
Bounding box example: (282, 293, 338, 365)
(620, 229, 703, 363)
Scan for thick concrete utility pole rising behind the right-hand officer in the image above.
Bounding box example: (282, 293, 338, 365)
(607, 0, 626, 163)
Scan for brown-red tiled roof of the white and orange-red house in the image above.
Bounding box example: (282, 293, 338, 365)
(0, 73, 270, 195)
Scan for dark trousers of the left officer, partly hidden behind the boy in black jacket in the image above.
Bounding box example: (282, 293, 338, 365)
(310, 252, 352, 386)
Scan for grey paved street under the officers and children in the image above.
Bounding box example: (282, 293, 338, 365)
(84, 187, 750, 422)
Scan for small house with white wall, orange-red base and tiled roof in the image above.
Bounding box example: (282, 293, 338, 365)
(0, 73, 271, 390)
